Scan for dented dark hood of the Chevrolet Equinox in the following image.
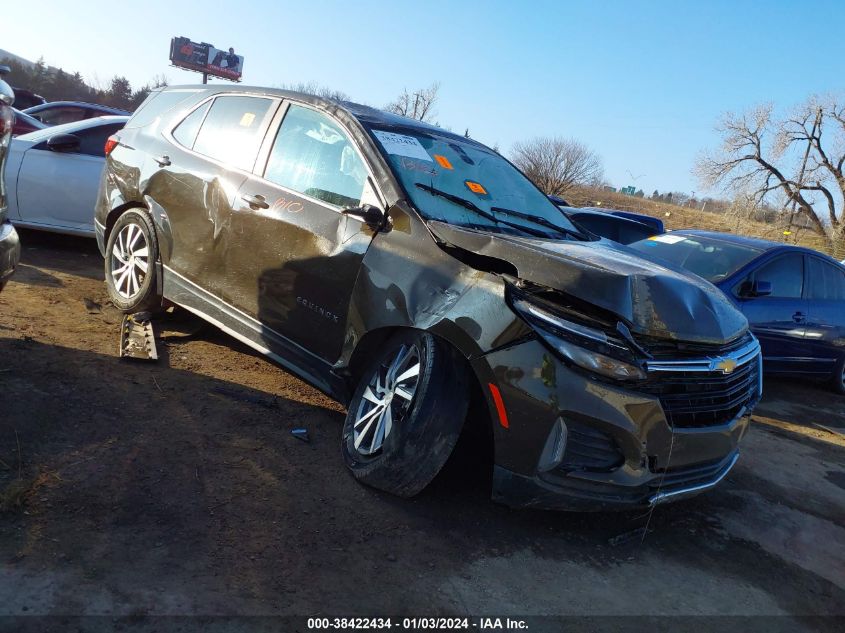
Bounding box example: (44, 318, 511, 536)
(429, 222, 748, 344)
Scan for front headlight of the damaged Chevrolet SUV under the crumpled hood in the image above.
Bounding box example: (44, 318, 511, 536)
(510, 297, 646, 380)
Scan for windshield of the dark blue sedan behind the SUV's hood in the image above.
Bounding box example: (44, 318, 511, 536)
(628, 233, 763, 283)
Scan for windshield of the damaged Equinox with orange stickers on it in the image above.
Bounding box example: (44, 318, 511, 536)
(370, 128, 579, 239)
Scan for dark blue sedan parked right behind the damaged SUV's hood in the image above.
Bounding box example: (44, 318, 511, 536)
(629, 230, 845, 394)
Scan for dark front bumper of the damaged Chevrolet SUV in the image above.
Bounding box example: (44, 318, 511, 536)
(475, 341, 759, 510)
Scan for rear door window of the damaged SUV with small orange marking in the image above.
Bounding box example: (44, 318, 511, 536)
(194, 96, 273, 171)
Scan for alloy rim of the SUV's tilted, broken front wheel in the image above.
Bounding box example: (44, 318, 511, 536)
(353, 345, 421, 455)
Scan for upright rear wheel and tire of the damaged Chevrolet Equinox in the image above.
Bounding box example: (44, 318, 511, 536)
(105, 209, 161, 314)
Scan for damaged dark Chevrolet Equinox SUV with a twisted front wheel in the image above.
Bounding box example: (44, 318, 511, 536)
(96, 86, 761, 510)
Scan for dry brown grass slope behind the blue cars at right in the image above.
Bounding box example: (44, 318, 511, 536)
(566, 188, 845, 260)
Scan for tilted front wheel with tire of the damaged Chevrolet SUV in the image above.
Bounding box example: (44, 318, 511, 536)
(341, 331, 469, 497)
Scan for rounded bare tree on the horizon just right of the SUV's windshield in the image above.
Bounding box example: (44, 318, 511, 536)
(511, 136, 604, 196)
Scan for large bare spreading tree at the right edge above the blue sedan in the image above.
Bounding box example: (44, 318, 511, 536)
(696, 98, 845, 250)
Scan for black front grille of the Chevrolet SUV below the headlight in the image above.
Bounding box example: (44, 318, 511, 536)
(643, 345, 760, 428)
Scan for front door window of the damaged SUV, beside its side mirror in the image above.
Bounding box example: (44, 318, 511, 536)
(264, 105, 367, 209)
